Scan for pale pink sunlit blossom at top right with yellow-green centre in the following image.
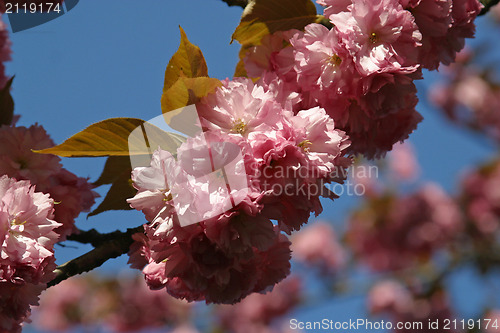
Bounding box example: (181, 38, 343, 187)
(329, 0, 422, 76)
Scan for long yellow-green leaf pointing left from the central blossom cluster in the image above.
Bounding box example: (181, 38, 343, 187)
(35, 118, 183, 157)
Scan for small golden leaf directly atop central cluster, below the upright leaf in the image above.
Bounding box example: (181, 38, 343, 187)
(161, 77, 222, 113)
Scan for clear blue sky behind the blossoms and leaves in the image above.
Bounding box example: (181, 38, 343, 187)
(4, 0, 498, 332)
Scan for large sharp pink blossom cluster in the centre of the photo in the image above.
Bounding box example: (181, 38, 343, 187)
(129, 79, 350, 303)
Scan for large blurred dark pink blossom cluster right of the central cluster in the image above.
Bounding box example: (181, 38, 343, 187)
(347, 184, 463, 271)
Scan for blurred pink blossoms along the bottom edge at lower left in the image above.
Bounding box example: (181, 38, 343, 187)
(33, 275, 190, 332)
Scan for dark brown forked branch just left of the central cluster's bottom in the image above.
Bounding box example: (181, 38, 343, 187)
(47, 226, 144, 287)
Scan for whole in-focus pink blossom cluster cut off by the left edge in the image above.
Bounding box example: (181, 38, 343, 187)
(0, 125, 97, 332)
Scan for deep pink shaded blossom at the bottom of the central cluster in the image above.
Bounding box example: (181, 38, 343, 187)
(137, 215, 290, 303)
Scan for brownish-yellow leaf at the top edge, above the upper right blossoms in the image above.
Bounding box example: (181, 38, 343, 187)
(232, 0, 317, 45)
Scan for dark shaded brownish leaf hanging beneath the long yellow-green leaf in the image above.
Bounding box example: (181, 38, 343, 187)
(88, 169, 137, 217)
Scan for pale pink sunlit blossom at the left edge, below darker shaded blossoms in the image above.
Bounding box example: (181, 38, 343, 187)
(0, 176, 61, 284)
